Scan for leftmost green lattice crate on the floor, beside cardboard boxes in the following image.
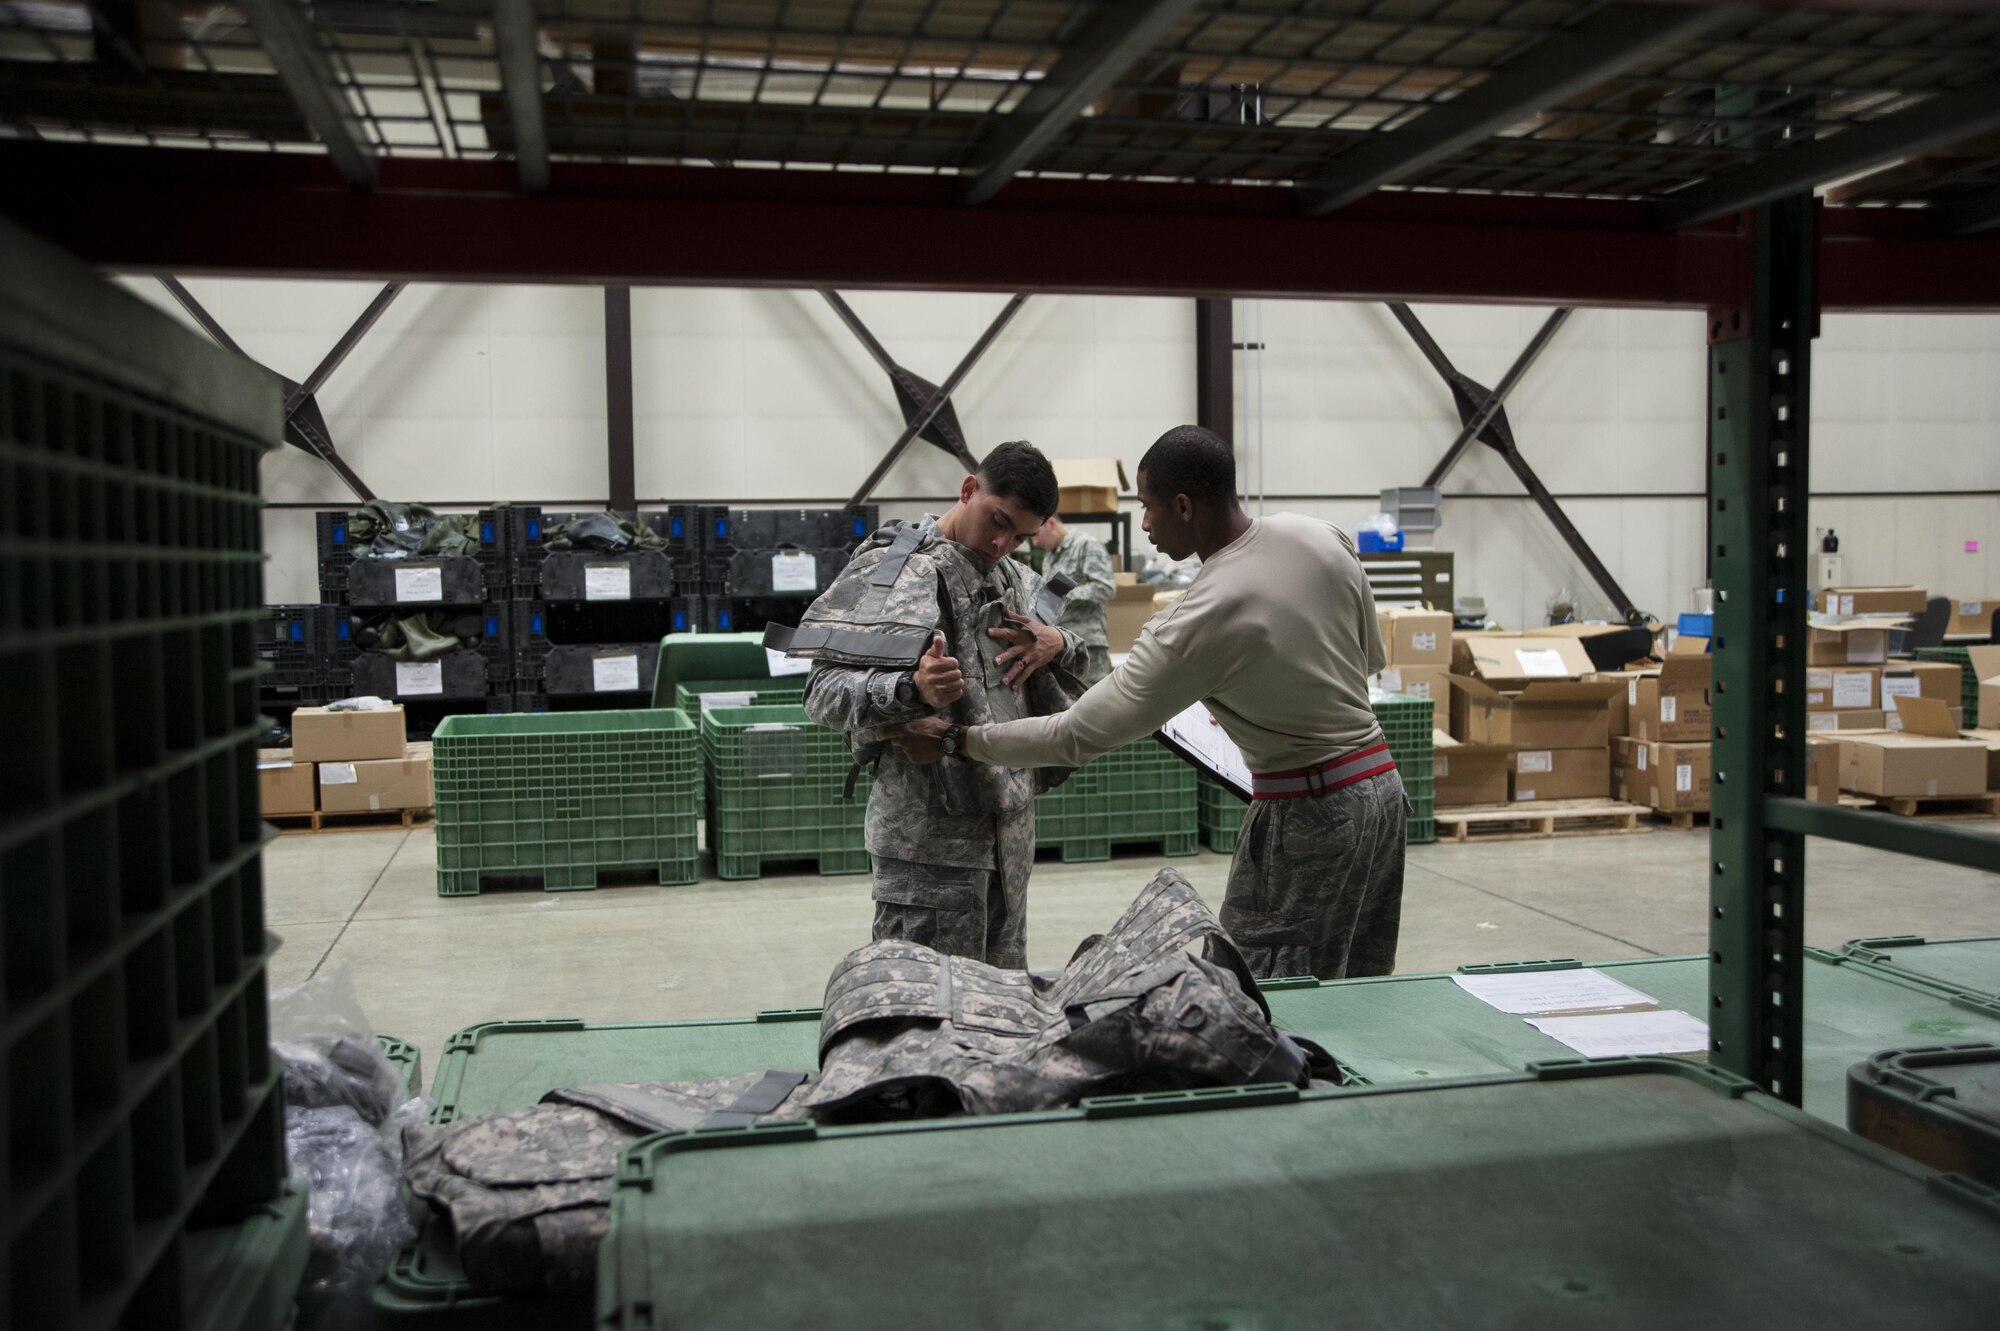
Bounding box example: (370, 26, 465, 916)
(432, 707, 700, 897)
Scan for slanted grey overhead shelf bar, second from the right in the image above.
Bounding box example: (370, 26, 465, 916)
(1296, 4, 1744, 216)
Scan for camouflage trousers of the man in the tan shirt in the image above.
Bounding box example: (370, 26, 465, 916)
(1220, 771, 1410, 979)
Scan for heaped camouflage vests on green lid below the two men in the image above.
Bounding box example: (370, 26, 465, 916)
(798, 869, 1340, 1121)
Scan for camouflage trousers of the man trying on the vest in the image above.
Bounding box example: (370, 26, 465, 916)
(870, 805, 1034, 969)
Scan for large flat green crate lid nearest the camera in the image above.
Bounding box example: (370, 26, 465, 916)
(596, 1059, 2000, 1331)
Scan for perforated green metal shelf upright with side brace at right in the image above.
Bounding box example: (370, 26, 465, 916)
(1706, 194, 2000, 1105)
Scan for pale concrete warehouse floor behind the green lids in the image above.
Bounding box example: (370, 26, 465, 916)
(264, 823, 2000, 1075)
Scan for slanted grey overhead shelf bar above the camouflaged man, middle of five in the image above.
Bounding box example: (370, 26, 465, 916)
(962, 0, 1194, 204)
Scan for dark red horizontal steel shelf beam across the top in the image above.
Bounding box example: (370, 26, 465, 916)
(0, 142, 2000, 310)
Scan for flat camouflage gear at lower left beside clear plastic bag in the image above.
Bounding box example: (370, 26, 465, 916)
(402, 1071, 806, 1295)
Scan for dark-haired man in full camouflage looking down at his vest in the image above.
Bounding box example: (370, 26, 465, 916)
(764, 444, 1086, 967)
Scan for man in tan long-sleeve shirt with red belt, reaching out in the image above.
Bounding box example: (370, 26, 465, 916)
(900, 426, 1408, 979)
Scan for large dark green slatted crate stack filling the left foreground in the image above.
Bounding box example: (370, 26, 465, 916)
(0, 212, 306, 1331)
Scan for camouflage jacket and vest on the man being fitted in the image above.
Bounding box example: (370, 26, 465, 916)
(784, 520, 1086, 869)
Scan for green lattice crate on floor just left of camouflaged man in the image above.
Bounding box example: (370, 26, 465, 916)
(702, 705, 870, 879)
